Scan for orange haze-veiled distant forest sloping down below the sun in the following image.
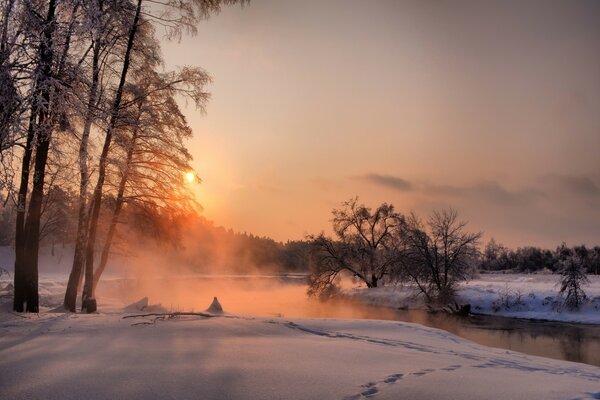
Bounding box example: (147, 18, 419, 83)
(0, 187, 309, 273)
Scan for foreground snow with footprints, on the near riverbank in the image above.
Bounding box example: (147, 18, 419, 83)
(0, 279, 600, 400)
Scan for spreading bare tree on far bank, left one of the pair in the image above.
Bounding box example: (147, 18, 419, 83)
(308, 198, 404, 294)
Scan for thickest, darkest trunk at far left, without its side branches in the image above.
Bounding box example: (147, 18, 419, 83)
(15, 0, 56, 312)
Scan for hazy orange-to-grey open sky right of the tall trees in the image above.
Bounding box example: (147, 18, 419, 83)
(163, 0, 600, 247)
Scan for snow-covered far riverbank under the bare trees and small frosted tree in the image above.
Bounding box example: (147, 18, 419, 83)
(344, 274, 600, 324)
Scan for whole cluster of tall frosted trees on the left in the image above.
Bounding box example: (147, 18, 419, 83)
(0, 0, 243, 312)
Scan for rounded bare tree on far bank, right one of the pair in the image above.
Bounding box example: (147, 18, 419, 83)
(401, 209, 482, 302)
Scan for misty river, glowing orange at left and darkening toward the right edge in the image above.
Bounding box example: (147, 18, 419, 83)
(98, 276, 600, 366)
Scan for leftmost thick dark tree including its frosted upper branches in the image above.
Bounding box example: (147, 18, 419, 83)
(11, 0, 80, 312)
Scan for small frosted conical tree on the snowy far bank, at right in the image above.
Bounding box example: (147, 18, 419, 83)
(559, 254, 589, 310)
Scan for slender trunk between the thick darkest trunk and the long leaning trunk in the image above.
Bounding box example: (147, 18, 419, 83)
(64, 28, 101, 312)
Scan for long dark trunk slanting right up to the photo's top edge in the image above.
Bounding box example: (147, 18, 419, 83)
(81, 0, 142, 310)
